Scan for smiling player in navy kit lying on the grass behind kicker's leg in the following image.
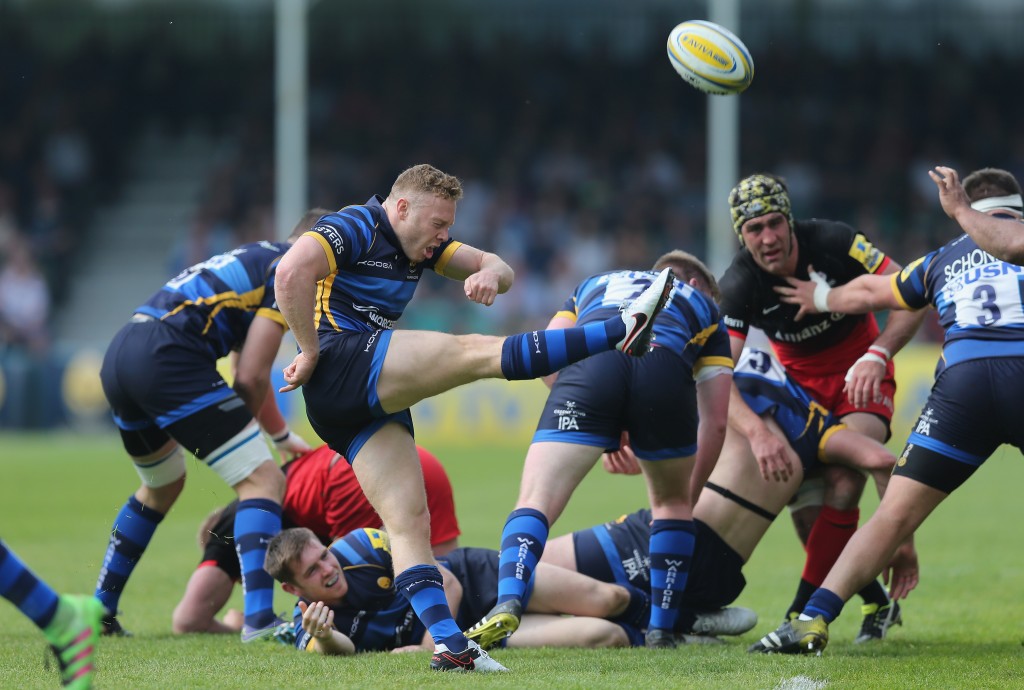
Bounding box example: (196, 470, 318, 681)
(265, 527, 650, 659)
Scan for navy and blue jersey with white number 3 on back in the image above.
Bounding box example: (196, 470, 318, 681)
(892, 228, 1024, 366)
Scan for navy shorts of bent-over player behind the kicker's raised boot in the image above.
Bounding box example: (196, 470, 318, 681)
(534, 348, 697, 461)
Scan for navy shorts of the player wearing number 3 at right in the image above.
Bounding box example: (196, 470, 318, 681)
(893, 357, 1024, 493)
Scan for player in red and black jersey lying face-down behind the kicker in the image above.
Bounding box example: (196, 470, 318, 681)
(172, 445, 459, 633)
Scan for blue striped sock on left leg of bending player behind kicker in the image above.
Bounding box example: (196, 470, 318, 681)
(96, 494, 164, 615)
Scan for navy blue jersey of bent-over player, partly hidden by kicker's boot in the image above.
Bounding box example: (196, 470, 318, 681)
(557, 270, 732, 377)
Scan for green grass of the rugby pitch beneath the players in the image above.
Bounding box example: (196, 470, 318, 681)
(0, 433, 1024, 690)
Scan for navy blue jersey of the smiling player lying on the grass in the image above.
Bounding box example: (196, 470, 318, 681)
(295, 528, 426, 652)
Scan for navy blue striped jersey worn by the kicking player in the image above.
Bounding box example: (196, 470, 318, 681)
(303, 197, 462, 335)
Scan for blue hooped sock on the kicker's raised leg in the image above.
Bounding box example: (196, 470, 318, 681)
(502, 314, 626, 381)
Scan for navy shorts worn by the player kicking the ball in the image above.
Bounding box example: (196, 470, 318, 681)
(302, 330, 415, 464)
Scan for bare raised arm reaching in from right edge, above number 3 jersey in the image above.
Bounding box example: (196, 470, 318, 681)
(928, 166, 1024, 264)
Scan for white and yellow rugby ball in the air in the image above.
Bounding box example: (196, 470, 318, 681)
(669, 19, 754, 95)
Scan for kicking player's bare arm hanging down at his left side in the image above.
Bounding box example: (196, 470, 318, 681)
(275, 236, 331, 393)
